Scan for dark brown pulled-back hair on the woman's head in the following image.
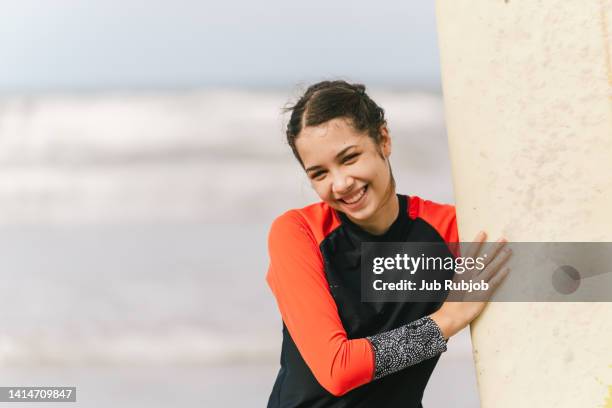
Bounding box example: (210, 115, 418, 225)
(284, 81, 387, 166)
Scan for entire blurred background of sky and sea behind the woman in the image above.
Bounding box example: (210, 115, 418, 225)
(0, 0, 479, 408)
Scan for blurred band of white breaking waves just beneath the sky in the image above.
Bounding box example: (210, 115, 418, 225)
(0, 90, 452, 224)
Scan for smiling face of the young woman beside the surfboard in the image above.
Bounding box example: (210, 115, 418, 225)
(296, 118, 398, 234)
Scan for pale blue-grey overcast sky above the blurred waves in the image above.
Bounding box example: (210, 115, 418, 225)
(0, 0, 440, 92)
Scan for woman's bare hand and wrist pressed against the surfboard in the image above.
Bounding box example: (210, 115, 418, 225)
(430, 231, 512, 339)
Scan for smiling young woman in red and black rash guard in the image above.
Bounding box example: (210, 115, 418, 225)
(266, 81, 509, 408)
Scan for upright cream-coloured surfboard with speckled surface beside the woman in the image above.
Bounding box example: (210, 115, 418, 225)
(436, 0, 612, 408)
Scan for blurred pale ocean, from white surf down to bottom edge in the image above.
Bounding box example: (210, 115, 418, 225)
(0, 89, 477, 407)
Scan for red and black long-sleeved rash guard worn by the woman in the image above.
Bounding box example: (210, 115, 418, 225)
(266, 195, 458, 408)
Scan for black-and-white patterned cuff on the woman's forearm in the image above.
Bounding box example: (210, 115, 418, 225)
(367, 316, 446, 379)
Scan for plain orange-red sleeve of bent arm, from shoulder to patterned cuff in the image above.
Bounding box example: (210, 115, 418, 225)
(266, 211, 374, 396)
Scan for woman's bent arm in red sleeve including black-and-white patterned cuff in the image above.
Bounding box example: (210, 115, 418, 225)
(266, 211, 454, 396)
